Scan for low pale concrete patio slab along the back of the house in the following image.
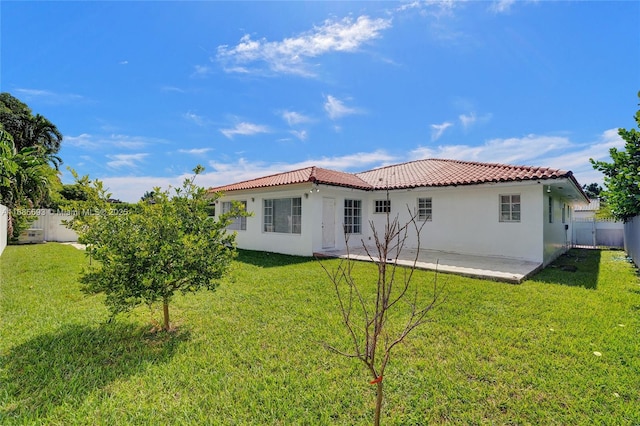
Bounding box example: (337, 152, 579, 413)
(314, 247, 542, 284)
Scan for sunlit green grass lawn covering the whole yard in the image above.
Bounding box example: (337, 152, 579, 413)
(0, 243, 640, 425)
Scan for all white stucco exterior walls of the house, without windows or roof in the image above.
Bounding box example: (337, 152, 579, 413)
(217, 182, 571, 263)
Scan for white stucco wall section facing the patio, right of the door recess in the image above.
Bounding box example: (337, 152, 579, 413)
(360, 182, 542, 262)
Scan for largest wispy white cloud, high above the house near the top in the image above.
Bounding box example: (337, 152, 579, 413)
(217, 16, 391, 76)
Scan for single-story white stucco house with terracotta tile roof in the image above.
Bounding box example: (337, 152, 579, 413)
(210, 159, 589, 266)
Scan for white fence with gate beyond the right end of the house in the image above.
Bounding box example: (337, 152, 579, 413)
(572, 218, 625, 248)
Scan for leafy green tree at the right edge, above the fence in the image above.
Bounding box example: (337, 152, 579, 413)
(589, 92, 640, 221)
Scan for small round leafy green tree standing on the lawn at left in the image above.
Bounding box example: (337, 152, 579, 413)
(79, 166, 244, 330)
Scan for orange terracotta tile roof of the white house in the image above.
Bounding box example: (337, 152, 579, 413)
(210, 159, 579, 192)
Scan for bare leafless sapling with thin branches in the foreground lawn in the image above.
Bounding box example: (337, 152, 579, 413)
(320, 198, 446, 426)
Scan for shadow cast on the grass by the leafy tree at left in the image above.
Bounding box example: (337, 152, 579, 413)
(0, 323, 189, 424)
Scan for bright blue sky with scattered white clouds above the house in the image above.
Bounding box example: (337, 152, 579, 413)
(0, 0, 640, 201)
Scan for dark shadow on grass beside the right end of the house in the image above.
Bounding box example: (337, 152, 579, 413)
(531, 249, 601, 290)
